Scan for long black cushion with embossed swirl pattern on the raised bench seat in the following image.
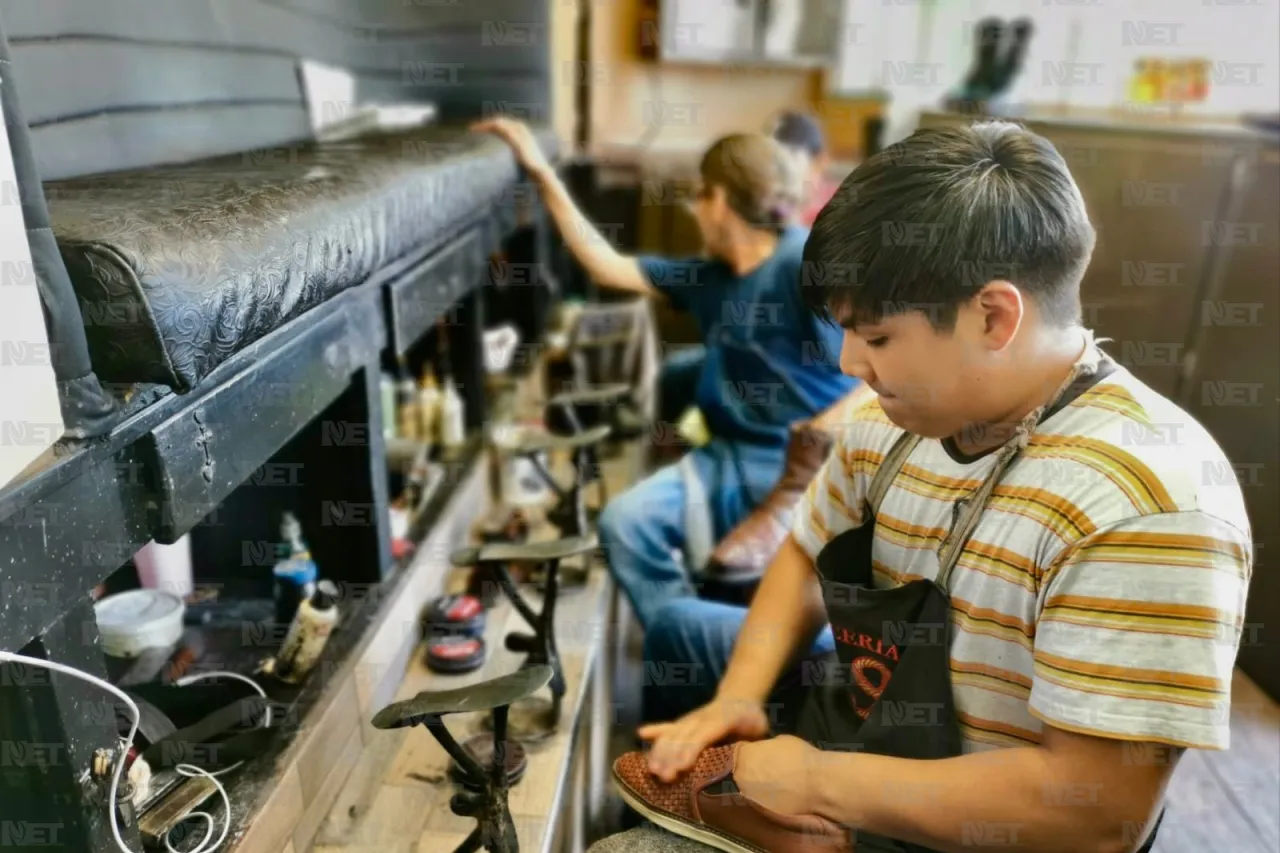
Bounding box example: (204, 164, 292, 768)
(45, 127, 535, 392)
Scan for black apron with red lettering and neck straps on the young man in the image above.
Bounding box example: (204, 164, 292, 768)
(796, 353, 1162, 853)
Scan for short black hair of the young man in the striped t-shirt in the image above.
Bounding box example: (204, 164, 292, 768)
(803, 122, 1094, 330)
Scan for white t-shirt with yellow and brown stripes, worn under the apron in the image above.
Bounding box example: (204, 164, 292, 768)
(792, 368, 1253, 752)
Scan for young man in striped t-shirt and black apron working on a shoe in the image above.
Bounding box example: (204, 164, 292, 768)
(596, 122, 1252, 853)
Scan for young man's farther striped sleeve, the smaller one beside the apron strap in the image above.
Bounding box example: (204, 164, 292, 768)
(791, 423, 878, 560)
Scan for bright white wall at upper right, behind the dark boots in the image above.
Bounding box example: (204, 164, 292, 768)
(832, 0, 1280, 141)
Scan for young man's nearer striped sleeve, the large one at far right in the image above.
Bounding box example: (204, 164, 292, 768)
(1029, 512, 1252, 749)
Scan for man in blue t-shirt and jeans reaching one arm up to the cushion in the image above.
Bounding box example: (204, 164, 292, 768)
(477, 119, 856, 625)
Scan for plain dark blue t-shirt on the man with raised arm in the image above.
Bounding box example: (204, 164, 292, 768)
(639, 228, 858, 446)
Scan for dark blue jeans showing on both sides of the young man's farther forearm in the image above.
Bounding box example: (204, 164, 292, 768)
(641, 598, 836, 730)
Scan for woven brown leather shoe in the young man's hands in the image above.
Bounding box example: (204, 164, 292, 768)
(613, 744, 854, 853)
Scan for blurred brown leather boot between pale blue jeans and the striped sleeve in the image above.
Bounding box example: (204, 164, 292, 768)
(707, 421, 835, 584)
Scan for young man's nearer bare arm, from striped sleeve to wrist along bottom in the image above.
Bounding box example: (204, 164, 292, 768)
(804, 726, 1180, 853)
